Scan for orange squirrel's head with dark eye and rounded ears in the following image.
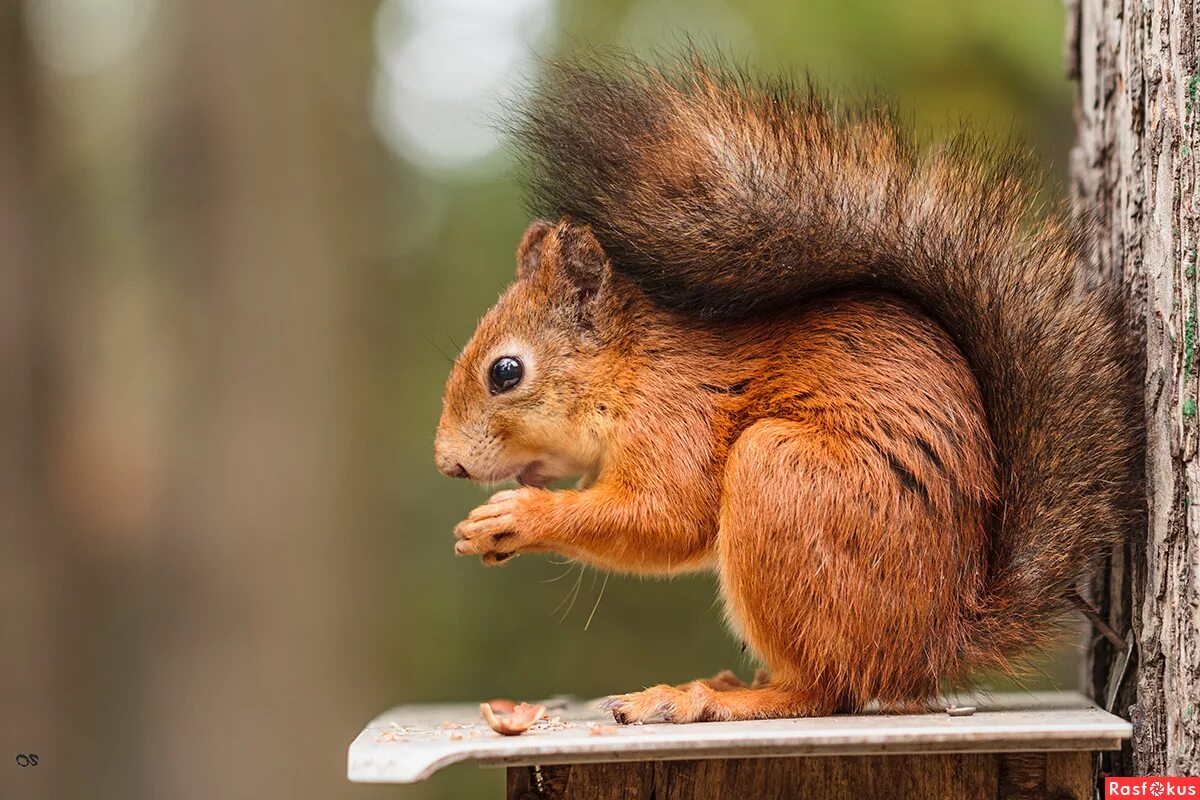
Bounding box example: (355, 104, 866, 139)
(434, 219, 613, 486)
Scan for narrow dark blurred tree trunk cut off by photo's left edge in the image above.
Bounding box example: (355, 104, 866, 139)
(0, 4, 65, 798)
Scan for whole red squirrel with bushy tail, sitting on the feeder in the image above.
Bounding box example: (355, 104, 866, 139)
(434, 54, 1144, 722)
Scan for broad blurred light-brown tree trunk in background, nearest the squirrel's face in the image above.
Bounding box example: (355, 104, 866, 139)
(146, 0, 381, 798)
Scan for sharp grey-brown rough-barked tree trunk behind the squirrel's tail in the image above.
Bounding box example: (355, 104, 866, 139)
(1068, 0, 1200, 774)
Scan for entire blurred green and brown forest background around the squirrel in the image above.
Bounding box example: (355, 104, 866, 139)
(0, 0, 1080, 799)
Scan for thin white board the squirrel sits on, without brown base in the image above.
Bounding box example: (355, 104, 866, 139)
(348, 692, 1132, 783)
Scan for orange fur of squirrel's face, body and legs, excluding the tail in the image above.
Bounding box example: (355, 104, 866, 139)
(438, 223, 997, 718)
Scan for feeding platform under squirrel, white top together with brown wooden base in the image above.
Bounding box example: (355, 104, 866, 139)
(348, 692, 1130, 800)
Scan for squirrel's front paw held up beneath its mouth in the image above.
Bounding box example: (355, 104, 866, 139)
(454, 488, 548, 566)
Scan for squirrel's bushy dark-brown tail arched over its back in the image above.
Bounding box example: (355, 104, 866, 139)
(516, 56, 1141, 663)
